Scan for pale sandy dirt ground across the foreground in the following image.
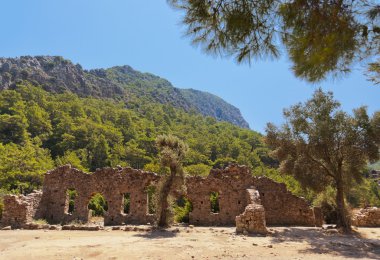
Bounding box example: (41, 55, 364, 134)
(0, 227, 380, 260)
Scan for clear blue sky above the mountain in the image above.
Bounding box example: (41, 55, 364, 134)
(0, 0, 380, 132)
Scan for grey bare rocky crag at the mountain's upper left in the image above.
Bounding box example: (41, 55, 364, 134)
(0, 56, 125, 98)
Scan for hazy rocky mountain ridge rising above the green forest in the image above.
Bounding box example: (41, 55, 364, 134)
(0, 56, 249, 128)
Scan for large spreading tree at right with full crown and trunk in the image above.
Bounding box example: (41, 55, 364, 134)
(266, 89, 380, 231)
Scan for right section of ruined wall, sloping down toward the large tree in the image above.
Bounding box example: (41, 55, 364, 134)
(187, 165, 323, 226)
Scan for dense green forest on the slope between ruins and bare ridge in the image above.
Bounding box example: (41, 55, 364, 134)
(0, 82, 380, 220)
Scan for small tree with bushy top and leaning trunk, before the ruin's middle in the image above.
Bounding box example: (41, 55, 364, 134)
(156, 135, 188, 227)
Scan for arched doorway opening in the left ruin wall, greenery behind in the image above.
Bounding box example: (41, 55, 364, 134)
(87, 193, 108, 225)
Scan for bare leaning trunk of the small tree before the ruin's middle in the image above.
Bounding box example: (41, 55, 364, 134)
(158, 168, 176, 227)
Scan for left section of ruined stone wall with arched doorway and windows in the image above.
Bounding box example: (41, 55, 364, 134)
(37, 166, 158, 225)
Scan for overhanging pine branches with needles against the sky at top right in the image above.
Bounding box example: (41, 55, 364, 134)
(167, 0, 380, 82)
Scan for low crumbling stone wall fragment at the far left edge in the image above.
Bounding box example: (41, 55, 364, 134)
(1, 191, 42, 228)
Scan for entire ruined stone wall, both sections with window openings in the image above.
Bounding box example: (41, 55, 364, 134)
(3, 165, 322, 226)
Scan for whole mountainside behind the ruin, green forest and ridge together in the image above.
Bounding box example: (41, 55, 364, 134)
(0, 58, 380, 219)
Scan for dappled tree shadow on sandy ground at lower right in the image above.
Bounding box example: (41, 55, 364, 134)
(271, 227, 380, 259)
